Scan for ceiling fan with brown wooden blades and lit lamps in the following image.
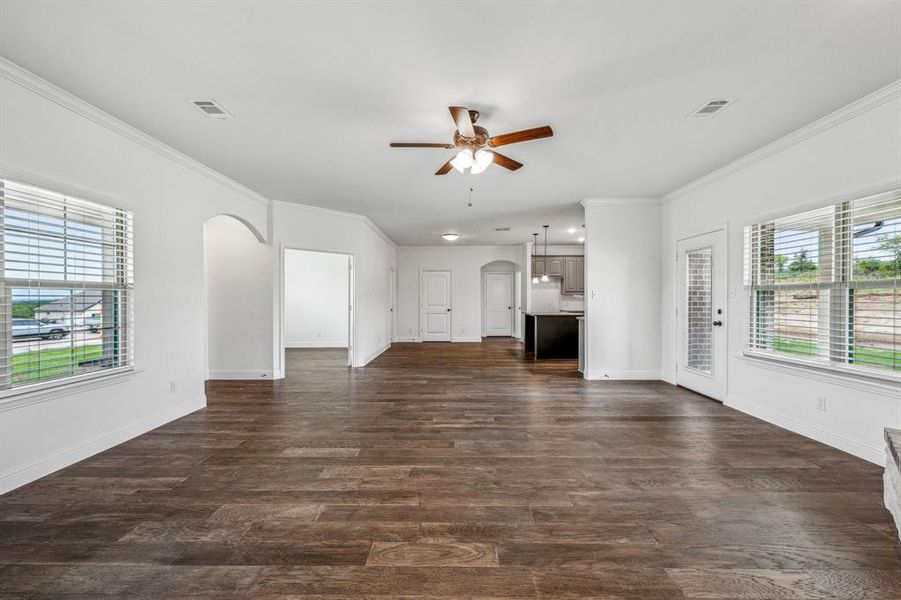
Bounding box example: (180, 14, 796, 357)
(391, 106, 554, 175)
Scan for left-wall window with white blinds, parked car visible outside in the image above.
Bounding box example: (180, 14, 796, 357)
(0, 179, 133, 394)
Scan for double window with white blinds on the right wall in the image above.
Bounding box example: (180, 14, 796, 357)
(745, 190, 901, 376)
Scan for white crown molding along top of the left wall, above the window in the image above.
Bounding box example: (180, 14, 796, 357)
(0, 57, 269, 206)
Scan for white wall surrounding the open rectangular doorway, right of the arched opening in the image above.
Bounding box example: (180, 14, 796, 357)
(272, 204, 397, 368)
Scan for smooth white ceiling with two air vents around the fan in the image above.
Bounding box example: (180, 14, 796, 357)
(0, 0, 901, 245)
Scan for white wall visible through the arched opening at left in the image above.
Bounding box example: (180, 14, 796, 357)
(203, 215, 273, 379)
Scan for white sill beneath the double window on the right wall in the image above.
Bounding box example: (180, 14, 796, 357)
(739, 351, 901, 399)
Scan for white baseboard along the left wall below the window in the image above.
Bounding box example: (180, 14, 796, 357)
(0, 396, 206, 494)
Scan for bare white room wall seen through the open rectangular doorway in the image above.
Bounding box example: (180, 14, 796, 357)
(285, 250, 348, 348)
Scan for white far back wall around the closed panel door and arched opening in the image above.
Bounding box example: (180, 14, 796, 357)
(397, 246, 523, 342)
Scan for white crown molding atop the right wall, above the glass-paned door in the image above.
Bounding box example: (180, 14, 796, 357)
(663, 79, 901, 204)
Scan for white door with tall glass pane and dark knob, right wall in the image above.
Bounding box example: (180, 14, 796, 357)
(676, 229, 727, 402)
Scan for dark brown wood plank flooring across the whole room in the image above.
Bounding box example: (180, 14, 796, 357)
(0, 340, 901, 600)
